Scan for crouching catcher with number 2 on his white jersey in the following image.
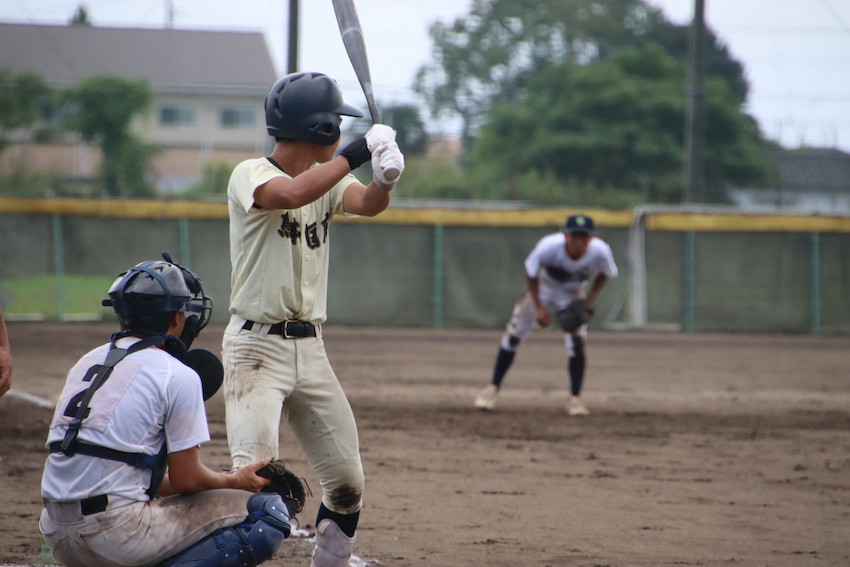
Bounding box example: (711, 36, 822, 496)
(39, 255, 290, 567)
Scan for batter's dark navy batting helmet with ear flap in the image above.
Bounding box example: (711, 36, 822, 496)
(266, 73, 363, 146)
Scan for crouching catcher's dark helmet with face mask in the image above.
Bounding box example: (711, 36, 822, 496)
(102, 252, 213, 349)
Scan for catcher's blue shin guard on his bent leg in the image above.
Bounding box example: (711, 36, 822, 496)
(157, 494, 291, 567)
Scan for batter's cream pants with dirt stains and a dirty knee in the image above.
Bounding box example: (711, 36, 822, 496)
(222, 315, 364, 514)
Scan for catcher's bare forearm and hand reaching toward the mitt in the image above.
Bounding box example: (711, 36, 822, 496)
(157, 447, 271, 496)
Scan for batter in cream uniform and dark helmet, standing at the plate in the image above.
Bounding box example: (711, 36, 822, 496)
(222, 73, 404, 567)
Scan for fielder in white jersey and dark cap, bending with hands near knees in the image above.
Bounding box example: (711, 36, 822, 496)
(475, 215, 617, 416)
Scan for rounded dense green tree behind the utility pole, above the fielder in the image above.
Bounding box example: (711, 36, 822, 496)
(470, 44, 772, 204)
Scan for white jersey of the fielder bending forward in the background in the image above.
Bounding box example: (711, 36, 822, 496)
(525, 232, 618, 308)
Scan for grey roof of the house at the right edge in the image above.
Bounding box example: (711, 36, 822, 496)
(771, 148, 850, 193)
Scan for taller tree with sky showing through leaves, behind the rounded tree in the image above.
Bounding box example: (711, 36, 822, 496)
(414, 0, 747, 148)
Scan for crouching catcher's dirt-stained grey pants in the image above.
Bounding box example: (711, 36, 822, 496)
(39, 489, 252, 567)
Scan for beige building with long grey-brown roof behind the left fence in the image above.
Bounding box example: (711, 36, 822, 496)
(0, 24, 277, 190)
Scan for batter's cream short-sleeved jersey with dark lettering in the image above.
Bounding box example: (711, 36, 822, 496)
(227, 158, 357, 325)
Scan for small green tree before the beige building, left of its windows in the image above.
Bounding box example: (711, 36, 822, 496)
(67, 75, 158, 197)
